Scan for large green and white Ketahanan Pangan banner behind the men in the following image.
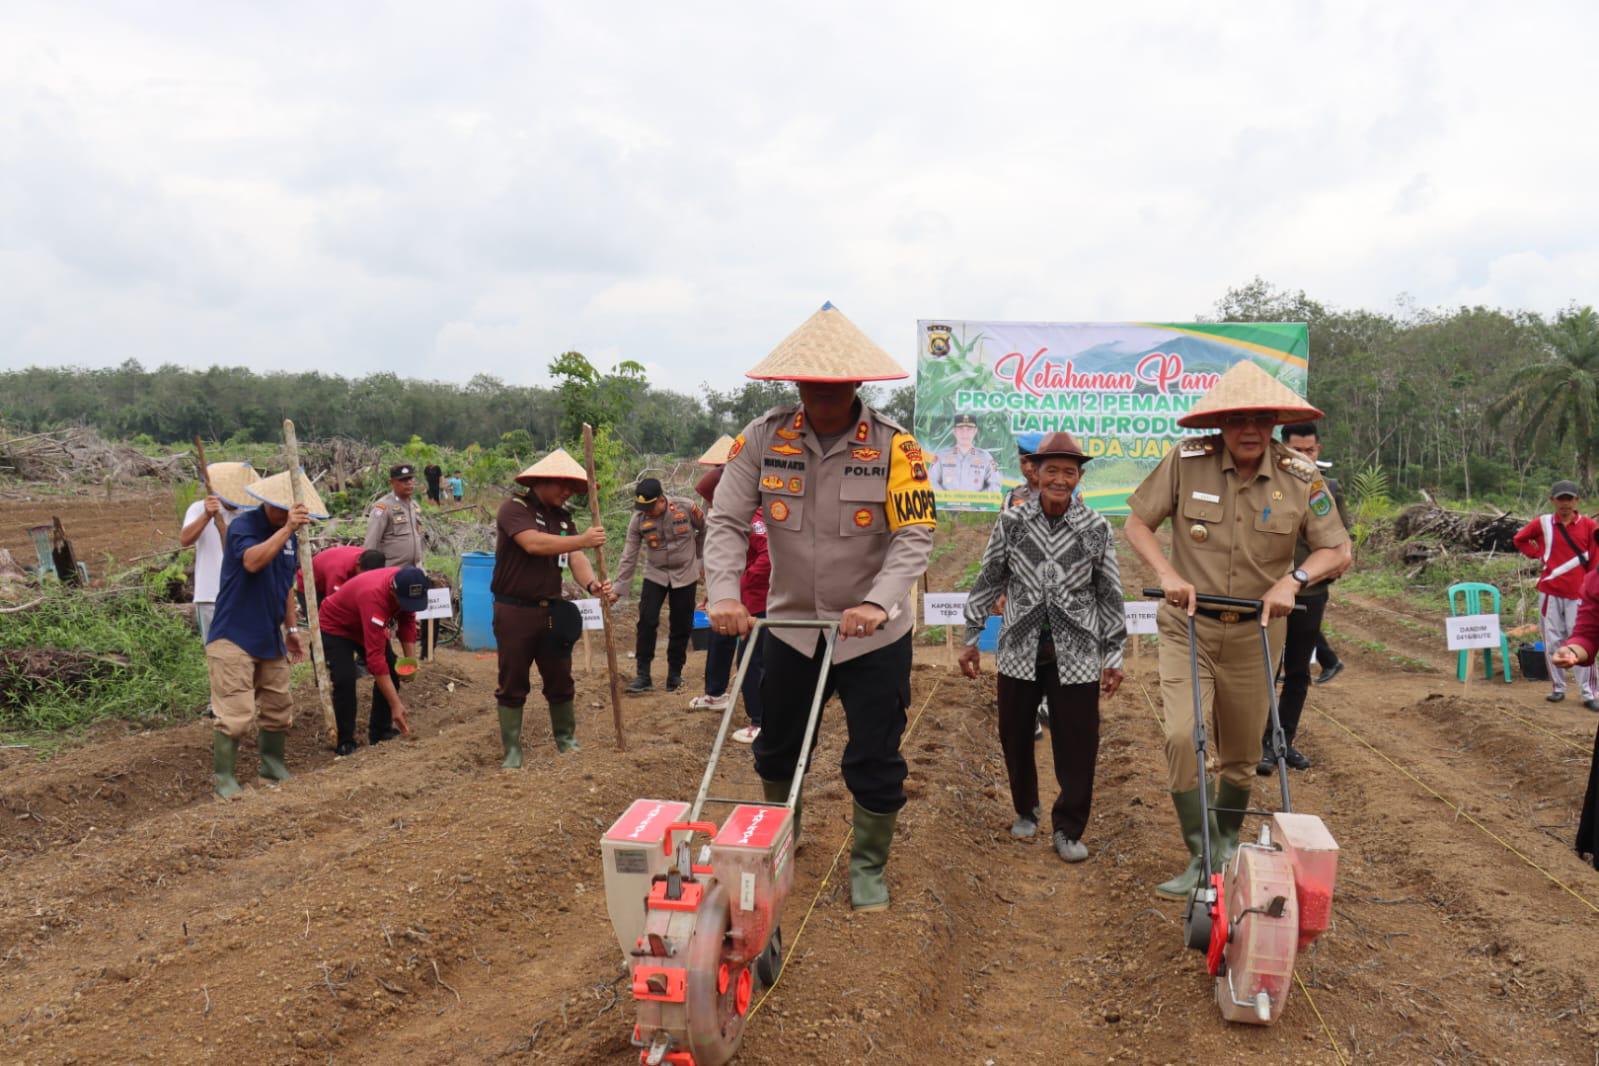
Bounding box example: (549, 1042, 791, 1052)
(915, 318, 1310, 515)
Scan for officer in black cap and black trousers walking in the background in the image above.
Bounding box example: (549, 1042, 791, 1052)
(614, 478, 705, 695)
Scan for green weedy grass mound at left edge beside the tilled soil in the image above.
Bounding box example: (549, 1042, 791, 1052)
(0, 588, 209, 735)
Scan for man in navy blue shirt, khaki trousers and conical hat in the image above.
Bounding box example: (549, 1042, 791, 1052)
(205, 473, 321, 799)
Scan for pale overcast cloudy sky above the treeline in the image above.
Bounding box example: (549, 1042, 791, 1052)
(0, 0, 1599, 390)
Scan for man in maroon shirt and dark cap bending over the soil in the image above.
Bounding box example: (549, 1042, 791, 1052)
(320, 566, 427, 756)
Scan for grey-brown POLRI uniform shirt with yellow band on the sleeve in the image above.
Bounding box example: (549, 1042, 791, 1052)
(705, 404, 937, 662)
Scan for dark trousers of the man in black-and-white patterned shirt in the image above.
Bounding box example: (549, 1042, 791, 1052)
(999, 660, 1099, 841)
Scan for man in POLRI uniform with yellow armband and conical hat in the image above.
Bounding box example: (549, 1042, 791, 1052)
(705, 304, 937, 911)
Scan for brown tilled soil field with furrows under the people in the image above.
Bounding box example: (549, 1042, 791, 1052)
(0, 549, 1599, 1064)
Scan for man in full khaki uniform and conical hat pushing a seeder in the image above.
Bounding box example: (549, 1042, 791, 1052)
(1127, 361, 1350, 900)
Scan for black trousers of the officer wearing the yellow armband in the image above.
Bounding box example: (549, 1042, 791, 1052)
(752, 633, 914, 813)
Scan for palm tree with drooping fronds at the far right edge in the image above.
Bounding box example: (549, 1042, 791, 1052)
(1489, 307, 1599, 489)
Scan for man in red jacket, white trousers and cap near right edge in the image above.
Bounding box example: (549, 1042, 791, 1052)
(1514, 481, 1599, 711)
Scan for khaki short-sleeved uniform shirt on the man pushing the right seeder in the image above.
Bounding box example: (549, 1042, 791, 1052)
(1127, 435, 1350, 599)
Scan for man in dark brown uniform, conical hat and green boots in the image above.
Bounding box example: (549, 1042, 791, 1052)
(489, 447, 616, 770)
